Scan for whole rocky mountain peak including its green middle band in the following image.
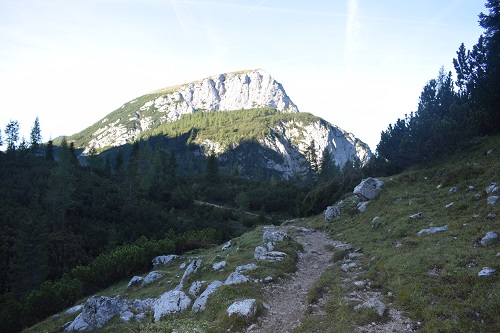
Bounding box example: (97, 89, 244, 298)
(68, 69, 371, 179)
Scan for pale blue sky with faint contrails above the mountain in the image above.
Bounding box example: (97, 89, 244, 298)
(0, 0, 487, 150)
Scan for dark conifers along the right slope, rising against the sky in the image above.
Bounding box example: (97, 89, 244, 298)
(372, 0, 500, 174)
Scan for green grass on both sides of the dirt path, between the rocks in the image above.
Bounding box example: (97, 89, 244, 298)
(26, 136, 500, 333)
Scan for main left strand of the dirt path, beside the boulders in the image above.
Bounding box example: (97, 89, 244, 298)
(248, 227, 336, 333)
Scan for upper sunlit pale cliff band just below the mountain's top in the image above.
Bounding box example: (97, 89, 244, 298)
(87, 70, 299, 151)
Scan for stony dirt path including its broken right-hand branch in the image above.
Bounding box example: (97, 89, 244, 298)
(247, 226, 413, 333)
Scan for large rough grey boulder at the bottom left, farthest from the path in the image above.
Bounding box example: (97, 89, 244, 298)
(66, 296, 130, 331)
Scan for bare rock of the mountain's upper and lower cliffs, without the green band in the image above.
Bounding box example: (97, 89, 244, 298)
(73, 70, 371, 178)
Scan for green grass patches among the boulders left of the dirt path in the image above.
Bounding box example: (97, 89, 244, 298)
(25, 227, 301, 333)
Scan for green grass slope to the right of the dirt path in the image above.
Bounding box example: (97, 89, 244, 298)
(299, 136, 500, 332)
